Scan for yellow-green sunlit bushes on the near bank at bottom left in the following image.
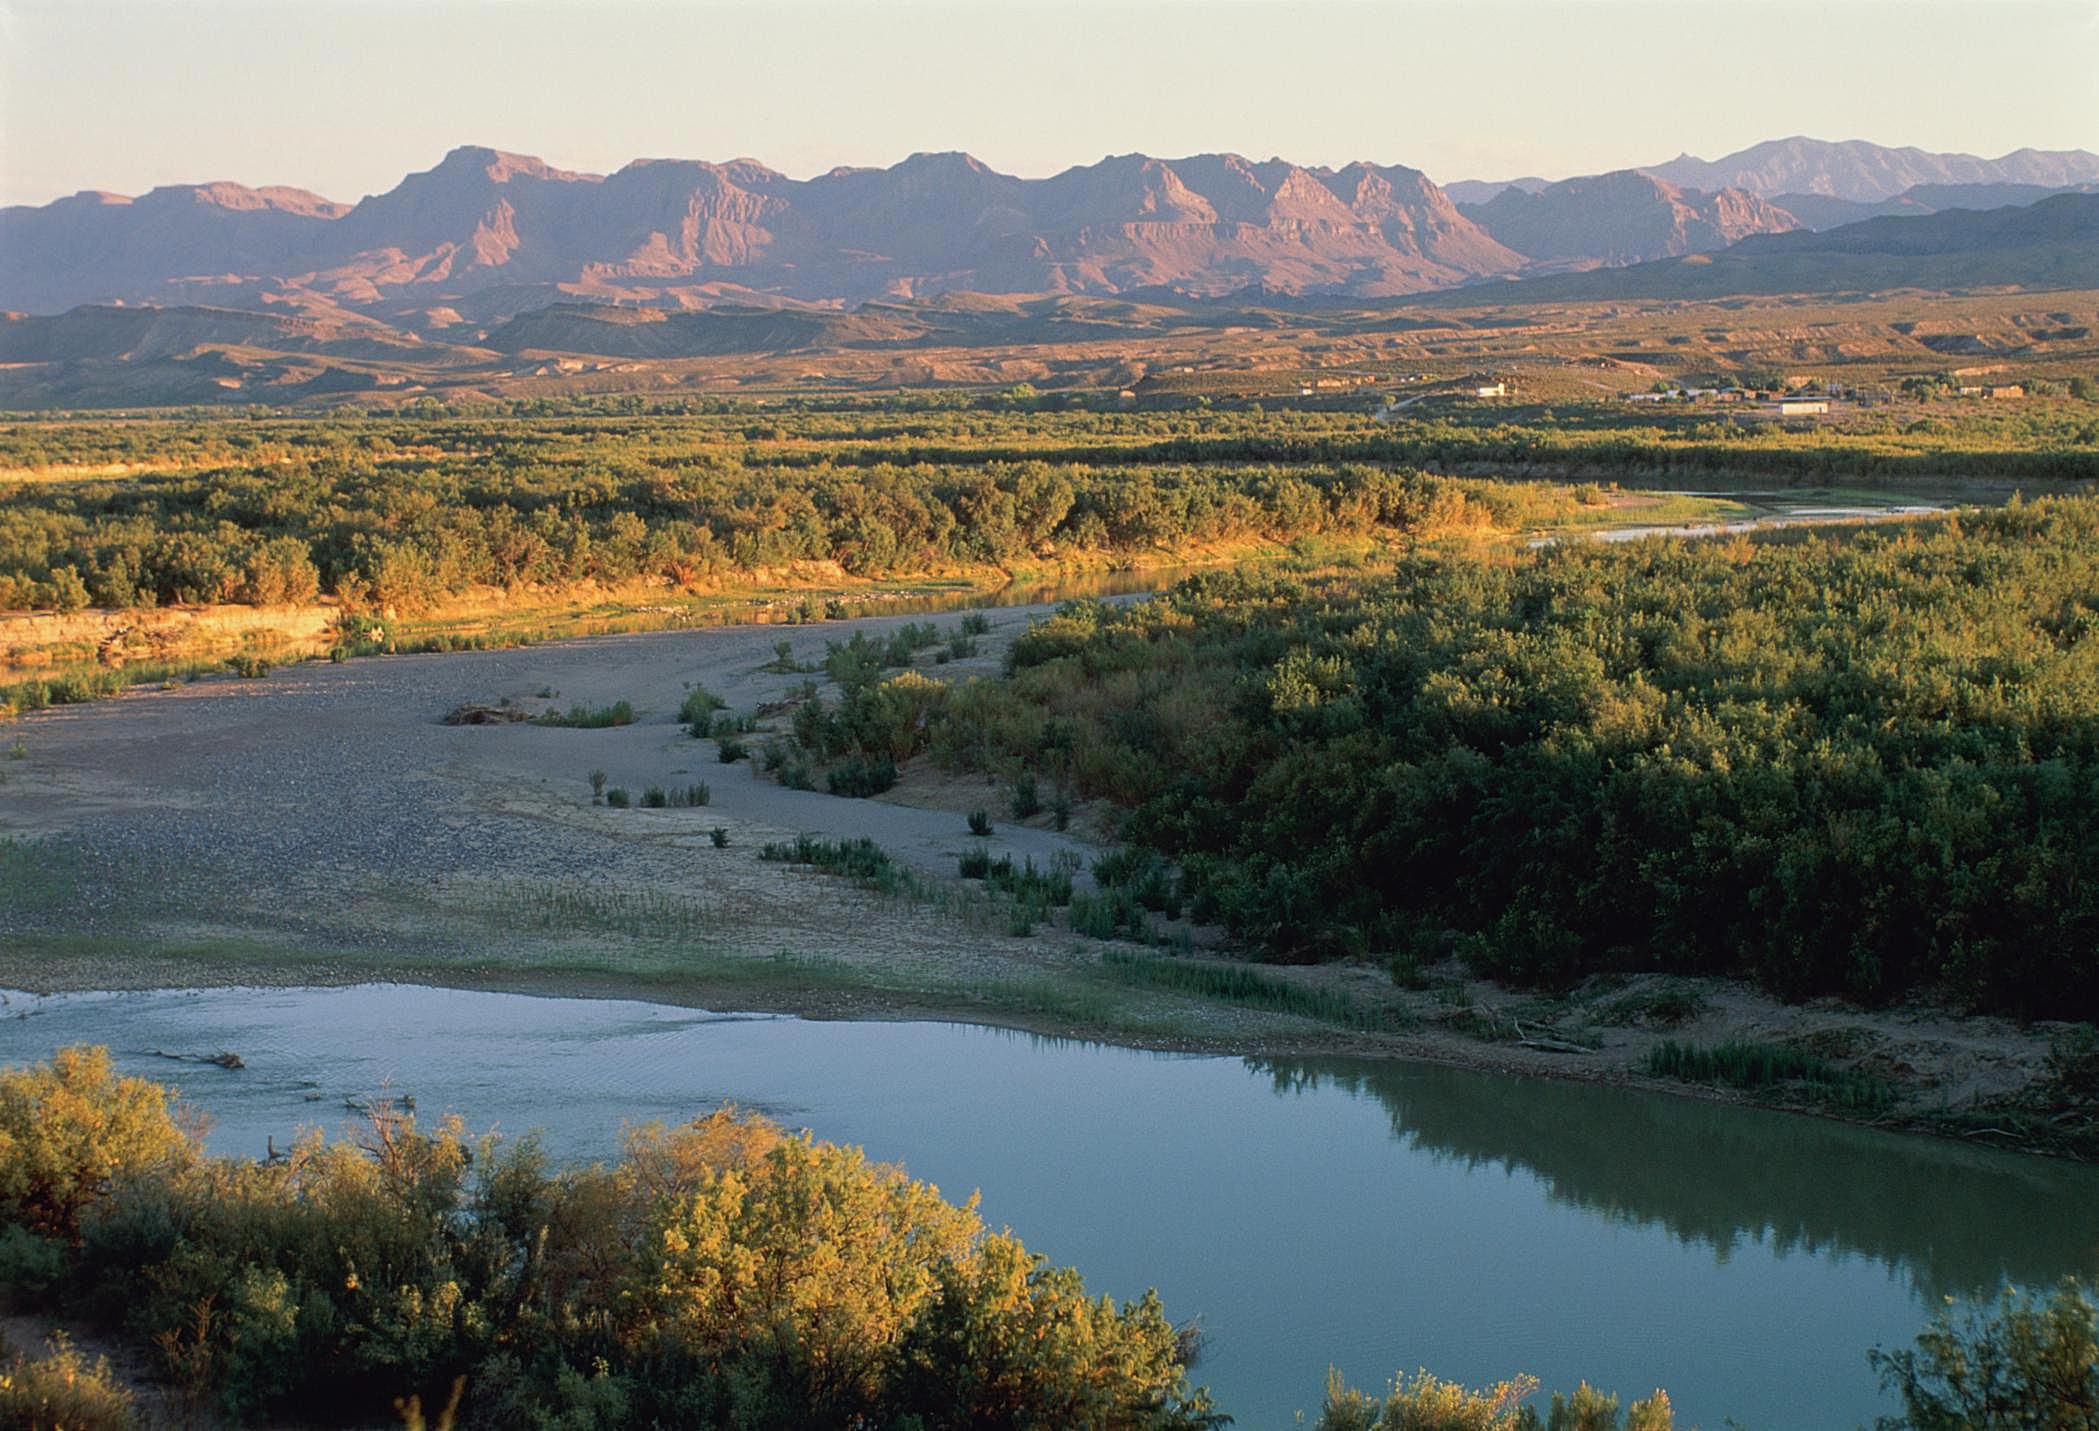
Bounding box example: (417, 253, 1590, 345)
(0, 1049, 1226, 1431)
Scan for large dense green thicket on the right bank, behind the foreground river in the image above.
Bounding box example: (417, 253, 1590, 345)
(930, 497, 2099, 1018)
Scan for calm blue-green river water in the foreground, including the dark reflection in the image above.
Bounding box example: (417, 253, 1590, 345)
(0, 984, 2099, 1429)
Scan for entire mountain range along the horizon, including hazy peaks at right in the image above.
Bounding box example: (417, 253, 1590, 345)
(12, 138, 2099, 321)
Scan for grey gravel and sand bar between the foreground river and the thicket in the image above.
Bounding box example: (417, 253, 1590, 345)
(0, 606, 2090, 1146)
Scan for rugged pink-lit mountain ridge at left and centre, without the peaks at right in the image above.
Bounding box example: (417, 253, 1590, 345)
(0, 147, 1524, 319)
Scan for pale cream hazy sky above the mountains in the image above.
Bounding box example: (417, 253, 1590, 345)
(0, 0, 2099, 204)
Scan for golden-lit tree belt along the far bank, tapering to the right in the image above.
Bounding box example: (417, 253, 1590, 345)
(0, 423, 1572, 611)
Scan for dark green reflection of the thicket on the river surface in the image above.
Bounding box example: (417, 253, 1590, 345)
(1247, 1060, 2099, 1301)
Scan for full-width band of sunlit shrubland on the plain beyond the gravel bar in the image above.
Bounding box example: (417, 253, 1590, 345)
(16, 401, 2099, 611)
